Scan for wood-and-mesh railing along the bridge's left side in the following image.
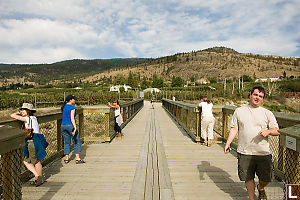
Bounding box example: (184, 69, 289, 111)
(0, 100, 143, 199)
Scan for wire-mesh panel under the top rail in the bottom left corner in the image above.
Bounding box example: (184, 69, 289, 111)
(1, 148, 22, 200)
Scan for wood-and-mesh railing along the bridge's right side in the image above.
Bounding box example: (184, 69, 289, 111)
(162, 99, 300, 184)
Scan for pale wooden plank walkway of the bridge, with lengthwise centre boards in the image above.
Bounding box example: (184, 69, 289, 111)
(22, 102, 283, 200)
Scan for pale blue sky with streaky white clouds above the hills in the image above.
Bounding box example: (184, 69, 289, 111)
(0, 0, 300, 64)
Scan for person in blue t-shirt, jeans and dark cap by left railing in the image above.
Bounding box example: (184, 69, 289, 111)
(61, 94, 85, 164)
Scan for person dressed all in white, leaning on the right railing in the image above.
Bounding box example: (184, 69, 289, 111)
(199, 97, 215, 147)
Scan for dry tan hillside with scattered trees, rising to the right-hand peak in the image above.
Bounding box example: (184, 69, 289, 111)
(83, 47, 300, 81)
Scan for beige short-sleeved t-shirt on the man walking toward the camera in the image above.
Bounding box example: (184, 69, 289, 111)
(231, 105, 278, 155)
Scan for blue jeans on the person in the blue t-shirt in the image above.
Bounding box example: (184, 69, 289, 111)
(61, 124, 81, 155)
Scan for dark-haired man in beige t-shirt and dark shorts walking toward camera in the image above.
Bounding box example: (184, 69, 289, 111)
(224, 86, 279, 200)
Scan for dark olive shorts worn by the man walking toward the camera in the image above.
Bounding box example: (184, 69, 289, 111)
(238, 153, 274, 182)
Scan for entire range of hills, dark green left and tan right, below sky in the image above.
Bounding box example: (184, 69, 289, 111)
(0, 47, 300, 86)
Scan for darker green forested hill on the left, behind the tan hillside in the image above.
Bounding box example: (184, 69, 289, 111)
(0, 58, 147, 86)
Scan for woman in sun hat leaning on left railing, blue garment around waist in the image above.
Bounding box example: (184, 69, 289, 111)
(10, 103, 48, 187)
